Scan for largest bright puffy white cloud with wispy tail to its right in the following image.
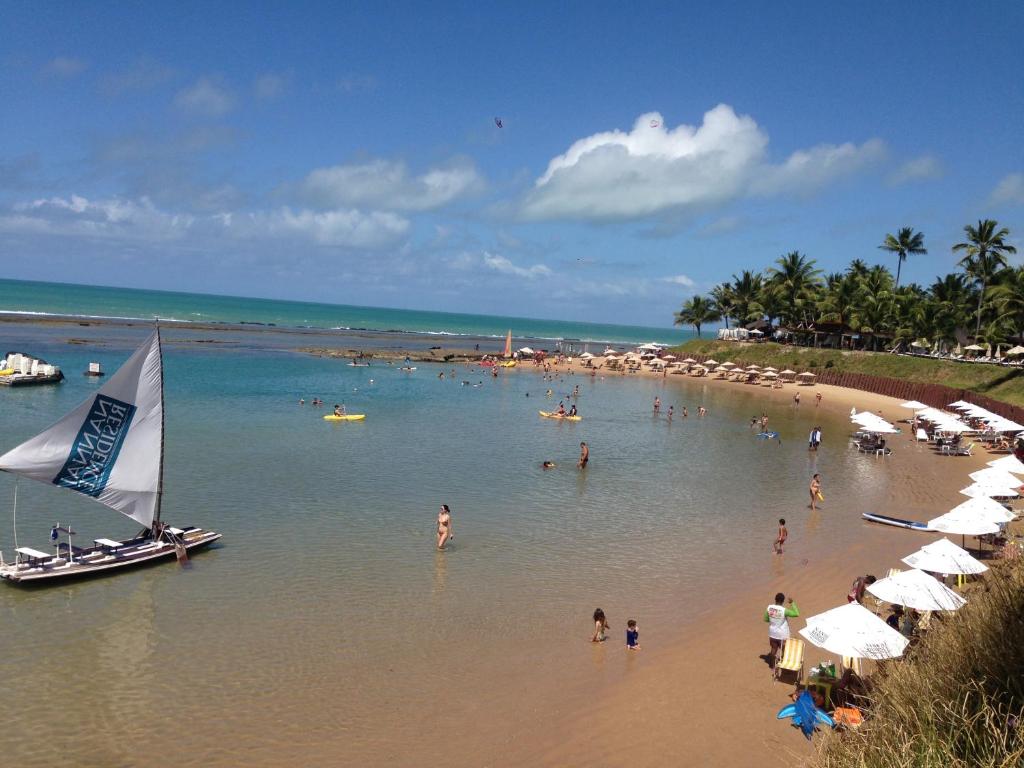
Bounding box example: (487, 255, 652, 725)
(521, 104, 884, 220)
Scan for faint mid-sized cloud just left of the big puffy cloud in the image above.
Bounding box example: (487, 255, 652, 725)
(302, 160, 481, 211)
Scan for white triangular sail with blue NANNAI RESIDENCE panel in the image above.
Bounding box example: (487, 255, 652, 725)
(0, 331, 164, 527)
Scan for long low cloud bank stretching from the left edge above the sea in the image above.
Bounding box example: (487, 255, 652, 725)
(0, 195, 411, 250)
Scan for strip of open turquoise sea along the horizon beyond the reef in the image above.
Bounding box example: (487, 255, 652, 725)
(0, 280, 692, 344)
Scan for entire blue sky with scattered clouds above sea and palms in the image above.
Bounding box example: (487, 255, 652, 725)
(0, 0, 1024, 327)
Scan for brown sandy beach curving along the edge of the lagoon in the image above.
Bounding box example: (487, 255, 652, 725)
(508, 356, 997, 768)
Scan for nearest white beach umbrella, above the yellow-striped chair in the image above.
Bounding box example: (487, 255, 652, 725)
(800, 603, 909, 659)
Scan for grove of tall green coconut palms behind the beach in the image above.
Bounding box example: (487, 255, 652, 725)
(676, 219, 1024, 350)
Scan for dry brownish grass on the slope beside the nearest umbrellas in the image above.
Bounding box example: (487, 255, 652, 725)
(814, 559, 1024, 768)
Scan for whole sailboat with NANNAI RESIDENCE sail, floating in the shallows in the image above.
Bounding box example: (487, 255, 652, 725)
(0, 328, 221, 584)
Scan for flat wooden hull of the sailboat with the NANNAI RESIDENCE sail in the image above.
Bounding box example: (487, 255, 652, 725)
(0, 528, 222, 585)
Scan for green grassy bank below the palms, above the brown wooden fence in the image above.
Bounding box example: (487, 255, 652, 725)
(672, 339, 1024, 406)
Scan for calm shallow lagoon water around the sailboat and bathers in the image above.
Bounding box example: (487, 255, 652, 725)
(0, 324, 889, 766)
